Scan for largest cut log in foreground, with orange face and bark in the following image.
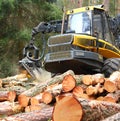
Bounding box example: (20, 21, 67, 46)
(52, 96, 120, 121)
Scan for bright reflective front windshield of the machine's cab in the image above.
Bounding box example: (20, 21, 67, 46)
(68, 11, 91, 34)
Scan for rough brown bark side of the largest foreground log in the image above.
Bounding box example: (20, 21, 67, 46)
(77, 98, 120, 121)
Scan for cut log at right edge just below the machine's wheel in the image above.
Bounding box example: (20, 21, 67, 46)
(104, 71, 120, 92)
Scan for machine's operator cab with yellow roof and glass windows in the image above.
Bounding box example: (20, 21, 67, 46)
(67, 7, 113, 43)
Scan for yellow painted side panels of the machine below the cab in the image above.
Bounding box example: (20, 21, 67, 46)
(72, 34, 120, 58)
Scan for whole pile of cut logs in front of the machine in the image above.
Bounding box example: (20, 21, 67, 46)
(0, 70, 120, 121)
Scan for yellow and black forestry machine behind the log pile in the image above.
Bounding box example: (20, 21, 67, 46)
(20, 5, 120, 77)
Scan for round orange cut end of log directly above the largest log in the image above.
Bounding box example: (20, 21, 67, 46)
(62, 74, 76, 92)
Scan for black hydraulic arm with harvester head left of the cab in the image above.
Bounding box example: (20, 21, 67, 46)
(19, 20, 66, 78)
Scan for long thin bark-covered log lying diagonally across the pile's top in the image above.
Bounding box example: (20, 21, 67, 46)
(19, 70, 74, 97)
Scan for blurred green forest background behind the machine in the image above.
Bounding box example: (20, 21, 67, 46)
(0, 0, 120, 78)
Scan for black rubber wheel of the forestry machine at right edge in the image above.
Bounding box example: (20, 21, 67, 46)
(101, 58, 120, 77)
